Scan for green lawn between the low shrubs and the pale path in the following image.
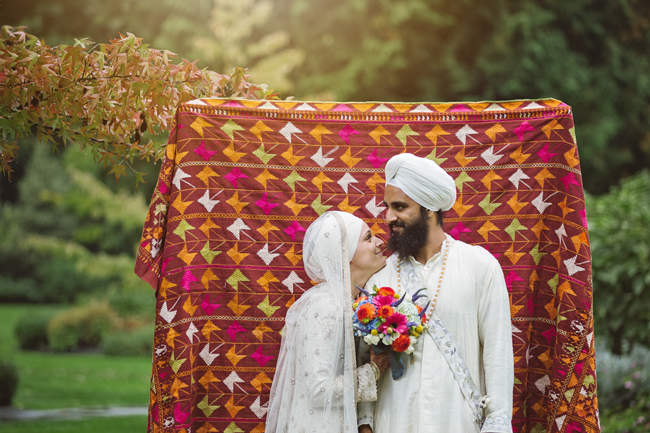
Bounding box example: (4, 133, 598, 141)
(0, 305, 151, 408)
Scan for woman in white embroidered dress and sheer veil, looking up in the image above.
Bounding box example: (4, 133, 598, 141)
(266, 212, 390, 433)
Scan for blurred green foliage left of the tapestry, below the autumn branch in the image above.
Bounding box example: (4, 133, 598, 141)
(0, 138, 150, 303)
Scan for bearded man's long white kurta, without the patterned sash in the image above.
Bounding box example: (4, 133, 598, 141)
(358, 236, 514, 433)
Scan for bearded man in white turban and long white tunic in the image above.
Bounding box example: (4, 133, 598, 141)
(358, 154, 514, 433)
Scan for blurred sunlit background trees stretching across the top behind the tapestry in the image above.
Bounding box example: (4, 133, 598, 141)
(3, 0, 650, 194)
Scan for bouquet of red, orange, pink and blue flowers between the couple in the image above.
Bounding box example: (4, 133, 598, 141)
(352, 286, 429, 379)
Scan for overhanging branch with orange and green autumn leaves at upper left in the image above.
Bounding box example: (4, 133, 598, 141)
(0, 26, 274, 182)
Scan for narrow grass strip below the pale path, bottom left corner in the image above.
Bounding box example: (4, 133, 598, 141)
(0, 416, 147, 433)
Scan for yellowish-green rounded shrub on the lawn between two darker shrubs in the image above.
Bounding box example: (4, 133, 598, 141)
(47, 302, 115, 352)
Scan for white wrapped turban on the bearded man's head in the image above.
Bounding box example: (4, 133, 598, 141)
(386, 153, 456, 212)
